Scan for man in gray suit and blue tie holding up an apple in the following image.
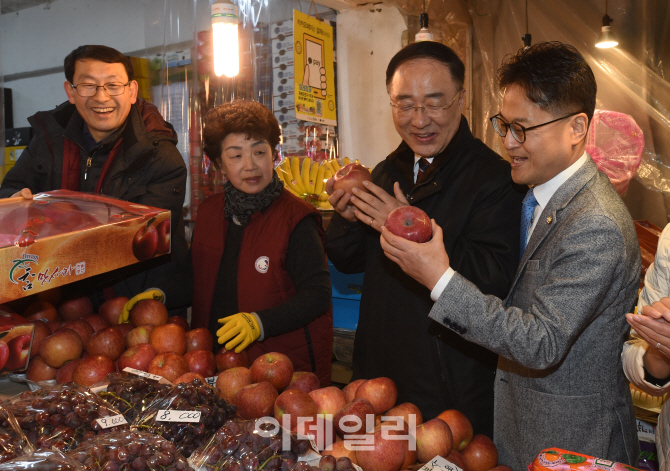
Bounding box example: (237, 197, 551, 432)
(381, 42, 640, 471)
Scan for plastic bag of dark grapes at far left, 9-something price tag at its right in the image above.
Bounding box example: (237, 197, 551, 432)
(2, 383, 129, 452)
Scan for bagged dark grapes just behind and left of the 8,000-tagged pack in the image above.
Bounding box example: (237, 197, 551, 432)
(98, 372, 173, 423)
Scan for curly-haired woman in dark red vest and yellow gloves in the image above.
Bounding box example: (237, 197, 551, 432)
(192, 100, 333, 386)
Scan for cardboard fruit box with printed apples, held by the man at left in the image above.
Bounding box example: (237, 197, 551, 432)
(0, 190, 170, 303)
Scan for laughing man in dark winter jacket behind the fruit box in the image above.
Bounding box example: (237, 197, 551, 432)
(0, 45, 187, 297)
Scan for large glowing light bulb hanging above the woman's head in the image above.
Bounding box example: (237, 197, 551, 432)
(212, 0, 240, 77)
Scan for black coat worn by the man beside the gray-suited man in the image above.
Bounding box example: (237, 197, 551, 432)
(326, 117, 523, 436)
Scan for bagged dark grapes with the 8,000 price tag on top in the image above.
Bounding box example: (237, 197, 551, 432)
(133, 379, 236, 458)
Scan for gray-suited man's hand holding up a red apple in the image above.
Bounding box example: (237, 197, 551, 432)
(380, 219, 449, 291)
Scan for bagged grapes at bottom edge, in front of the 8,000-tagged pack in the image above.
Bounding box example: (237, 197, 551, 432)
(69, 432, 193, 471)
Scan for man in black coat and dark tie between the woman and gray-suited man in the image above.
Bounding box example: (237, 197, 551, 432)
(326, 41, 523, 436)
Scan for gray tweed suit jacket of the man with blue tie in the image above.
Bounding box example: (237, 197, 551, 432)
(430, 158, 640, 471)
